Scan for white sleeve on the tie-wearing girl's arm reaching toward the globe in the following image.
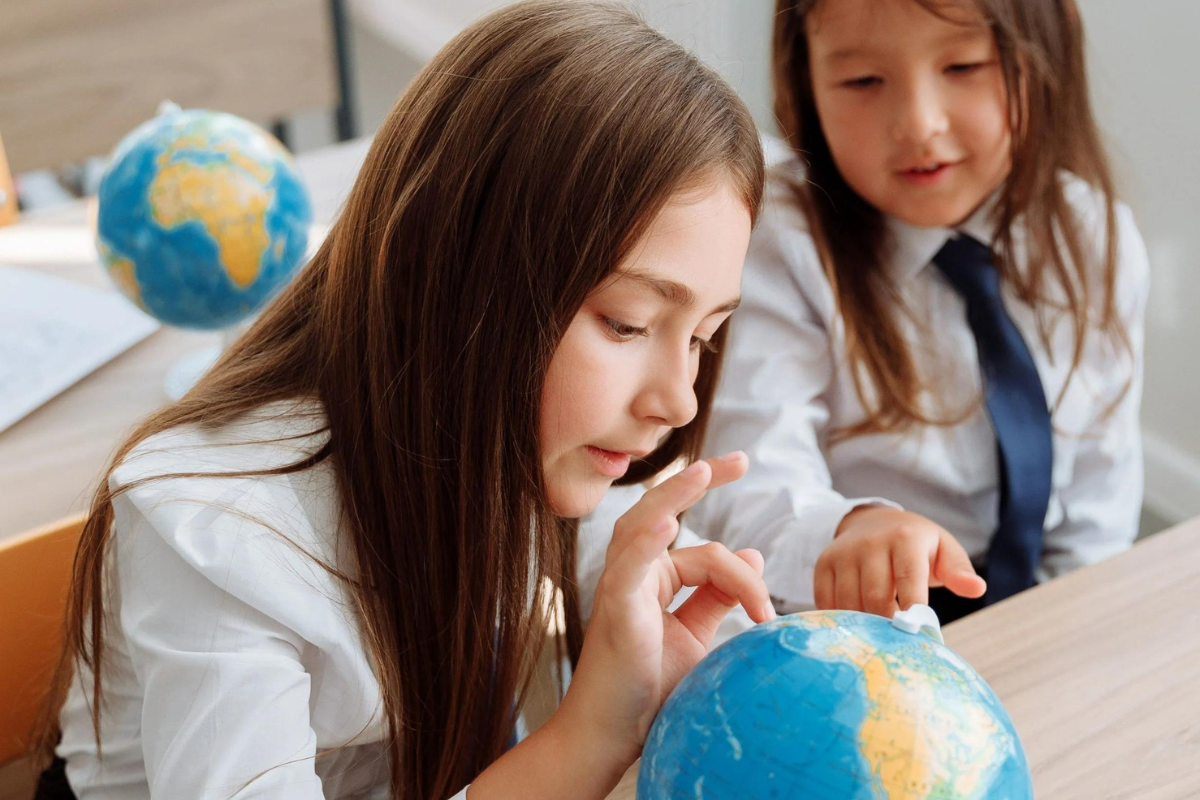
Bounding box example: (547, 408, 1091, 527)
(688, 181, 895, 612)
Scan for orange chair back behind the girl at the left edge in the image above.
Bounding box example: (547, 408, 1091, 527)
(0, 516, 85, 764)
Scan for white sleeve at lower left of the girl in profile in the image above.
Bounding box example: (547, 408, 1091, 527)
(114, 481, 324, 800)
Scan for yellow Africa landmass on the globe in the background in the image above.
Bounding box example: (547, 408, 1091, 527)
(150, 137, 272, 288)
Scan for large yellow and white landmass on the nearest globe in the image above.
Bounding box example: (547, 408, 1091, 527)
(806, 613, 1006, 800)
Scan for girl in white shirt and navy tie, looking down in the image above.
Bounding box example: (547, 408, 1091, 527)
(690, 0, 1148, 621)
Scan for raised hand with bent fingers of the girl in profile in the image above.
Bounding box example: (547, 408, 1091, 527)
(556, 452, 775, 764)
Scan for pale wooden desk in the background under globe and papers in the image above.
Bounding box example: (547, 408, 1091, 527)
(0, 139, 370, 539)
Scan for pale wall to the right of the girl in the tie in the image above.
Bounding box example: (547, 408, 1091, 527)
(1080, 0, 1200, 519)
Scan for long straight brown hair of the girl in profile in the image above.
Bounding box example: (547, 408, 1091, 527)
(44, 0, 763, 800)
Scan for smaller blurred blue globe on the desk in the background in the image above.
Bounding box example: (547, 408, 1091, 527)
(96, 107, 312, 329)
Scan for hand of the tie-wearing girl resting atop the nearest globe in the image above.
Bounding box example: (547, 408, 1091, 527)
(814, 506, 988, 618)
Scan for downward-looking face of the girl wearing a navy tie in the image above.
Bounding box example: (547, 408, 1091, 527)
(806, 0, 1010, 227)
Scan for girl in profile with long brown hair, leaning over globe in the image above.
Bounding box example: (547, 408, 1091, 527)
(37, 0, 773, 800)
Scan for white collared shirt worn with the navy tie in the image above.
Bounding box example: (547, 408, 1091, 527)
(688, 140, 1148, 610)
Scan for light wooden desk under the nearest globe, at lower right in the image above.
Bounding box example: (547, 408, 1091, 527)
(608, 518, 1200, 800)
